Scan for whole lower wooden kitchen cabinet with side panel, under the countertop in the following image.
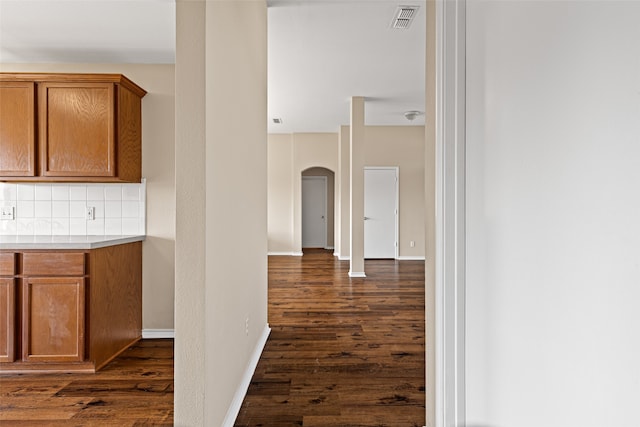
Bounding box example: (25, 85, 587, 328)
(0, 242, 142, 372)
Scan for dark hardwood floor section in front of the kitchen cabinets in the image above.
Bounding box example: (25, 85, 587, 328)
(0, 340, 173, 427)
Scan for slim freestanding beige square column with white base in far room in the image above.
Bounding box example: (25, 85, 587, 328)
(349, 96, 366, 277)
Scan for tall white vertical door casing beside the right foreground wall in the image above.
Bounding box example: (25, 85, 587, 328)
(435, 0, 466, 427)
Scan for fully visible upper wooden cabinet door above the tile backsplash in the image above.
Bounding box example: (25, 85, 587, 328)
(38, 83, 116, 177)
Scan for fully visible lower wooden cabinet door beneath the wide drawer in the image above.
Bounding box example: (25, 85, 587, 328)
(22, 277, 85, 362)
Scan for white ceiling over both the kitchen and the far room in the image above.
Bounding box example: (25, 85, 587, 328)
(0, 0, 425, 133)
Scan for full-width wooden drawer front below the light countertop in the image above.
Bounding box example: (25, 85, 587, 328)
(22, 252, 85, 276)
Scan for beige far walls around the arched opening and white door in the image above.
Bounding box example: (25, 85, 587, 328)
(268, 126, 425, 258)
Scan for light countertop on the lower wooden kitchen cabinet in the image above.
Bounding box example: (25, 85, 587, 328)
(0, 235, 145, 250)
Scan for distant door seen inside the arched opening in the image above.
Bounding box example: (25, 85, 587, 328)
(302, 176, 327, 248)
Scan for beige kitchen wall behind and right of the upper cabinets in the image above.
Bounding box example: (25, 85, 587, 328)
(0, 64, 176, 330)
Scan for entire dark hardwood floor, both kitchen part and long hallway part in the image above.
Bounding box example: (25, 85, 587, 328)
(0, 251, 425, 427)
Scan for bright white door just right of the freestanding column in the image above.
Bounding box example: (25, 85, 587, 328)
(364, 168, 398, 258)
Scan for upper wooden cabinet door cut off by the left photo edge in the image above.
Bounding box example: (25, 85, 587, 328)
(0, 82, 36, 177)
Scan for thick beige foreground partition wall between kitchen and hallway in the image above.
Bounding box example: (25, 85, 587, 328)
(175, 0, 268, 426)
